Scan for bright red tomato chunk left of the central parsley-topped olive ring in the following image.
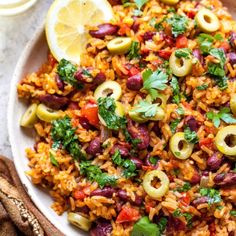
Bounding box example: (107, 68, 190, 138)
(81, 103, 99, 126)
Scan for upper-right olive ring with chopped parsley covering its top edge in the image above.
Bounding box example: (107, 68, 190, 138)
(169, 51, 192, 77)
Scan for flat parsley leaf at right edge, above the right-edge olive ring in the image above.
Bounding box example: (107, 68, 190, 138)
(206, 107, 236, 128)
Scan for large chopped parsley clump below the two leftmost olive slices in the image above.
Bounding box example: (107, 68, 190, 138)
(51, 116, 85, 160)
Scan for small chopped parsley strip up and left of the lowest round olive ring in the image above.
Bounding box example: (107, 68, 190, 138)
(111, 150, 137, 178)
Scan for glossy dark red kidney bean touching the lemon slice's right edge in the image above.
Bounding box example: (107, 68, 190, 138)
(89, 23, 119, 39)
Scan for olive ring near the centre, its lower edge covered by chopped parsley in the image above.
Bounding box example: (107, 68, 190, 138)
(94, 80, 122, 100)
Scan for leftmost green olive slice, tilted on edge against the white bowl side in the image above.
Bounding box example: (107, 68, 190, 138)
(20, 104, 38, 128)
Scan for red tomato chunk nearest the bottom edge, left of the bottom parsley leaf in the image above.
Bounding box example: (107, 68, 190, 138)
(116, 206, 141, 223)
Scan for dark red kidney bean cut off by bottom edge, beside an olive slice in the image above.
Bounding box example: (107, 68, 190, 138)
(89, 218, 112, 236)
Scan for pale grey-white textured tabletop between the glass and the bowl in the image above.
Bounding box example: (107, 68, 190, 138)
(0, 0, 53, 158)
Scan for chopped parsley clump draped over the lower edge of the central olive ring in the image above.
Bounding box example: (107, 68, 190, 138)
(98, 97, 126, 130)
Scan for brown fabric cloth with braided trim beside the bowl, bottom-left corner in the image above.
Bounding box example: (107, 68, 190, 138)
(0, 156, 64, 236)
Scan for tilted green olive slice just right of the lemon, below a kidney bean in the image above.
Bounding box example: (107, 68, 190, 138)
(107, 37, 132, 54)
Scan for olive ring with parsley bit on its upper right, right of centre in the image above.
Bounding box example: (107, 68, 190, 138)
(169, 132, 194, 160)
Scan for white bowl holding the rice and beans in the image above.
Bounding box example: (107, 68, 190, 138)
(8, 0, 236, 236)
